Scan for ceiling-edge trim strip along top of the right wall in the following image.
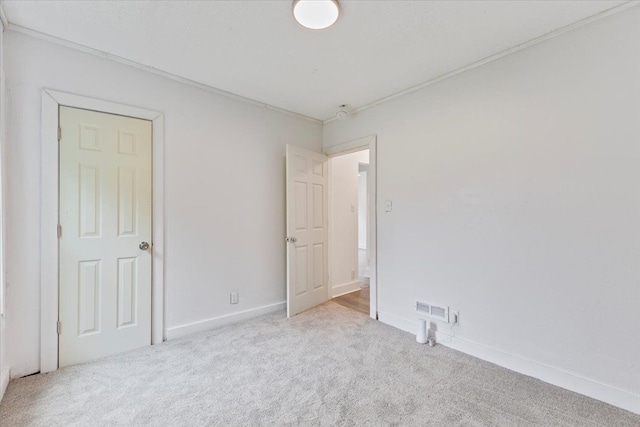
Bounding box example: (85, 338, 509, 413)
(322, 0, 640, 124)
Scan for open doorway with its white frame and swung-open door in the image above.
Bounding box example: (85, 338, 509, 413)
(285, 135, 378, 319)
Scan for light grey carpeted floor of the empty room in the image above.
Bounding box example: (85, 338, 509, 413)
(0, 302, 640, 427)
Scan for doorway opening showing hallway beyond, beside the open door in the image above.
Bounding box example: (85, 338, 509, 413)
(329, 149, 371, 315)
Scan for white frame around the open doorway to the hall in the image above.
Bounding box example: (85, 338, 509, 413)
(323, 135, 378, 319)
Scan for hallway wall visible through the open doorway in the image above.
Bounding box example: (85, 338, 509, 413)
(329, 150, 369, 297)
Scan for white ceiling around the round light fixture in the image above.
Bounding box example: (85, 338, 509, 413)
(3, 0, 624, 120)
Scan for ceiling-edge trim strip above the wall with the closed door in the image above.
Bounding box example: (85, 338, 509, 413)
(6, 23, 322, 124)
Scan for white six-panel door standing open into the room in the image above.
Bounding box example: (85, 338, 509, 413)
(287, 145, 329, 317)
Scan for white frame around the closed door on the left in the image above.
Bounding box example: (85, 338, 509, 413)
(40, 89, 166, 373)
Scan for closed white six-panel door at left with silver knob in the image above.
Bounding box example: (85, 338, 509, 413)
(59, 107, 152, 367)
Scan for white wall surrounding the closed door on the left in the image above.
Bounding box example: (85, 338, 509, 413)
(5, 31, 322, 377)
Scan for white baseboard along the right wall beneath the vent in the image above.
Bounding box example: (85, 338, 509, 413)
(378, 312, 640, 414)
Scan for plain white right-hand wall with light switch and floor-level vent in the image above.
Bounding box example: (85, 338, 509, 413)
(324, 7, 640, 412)
